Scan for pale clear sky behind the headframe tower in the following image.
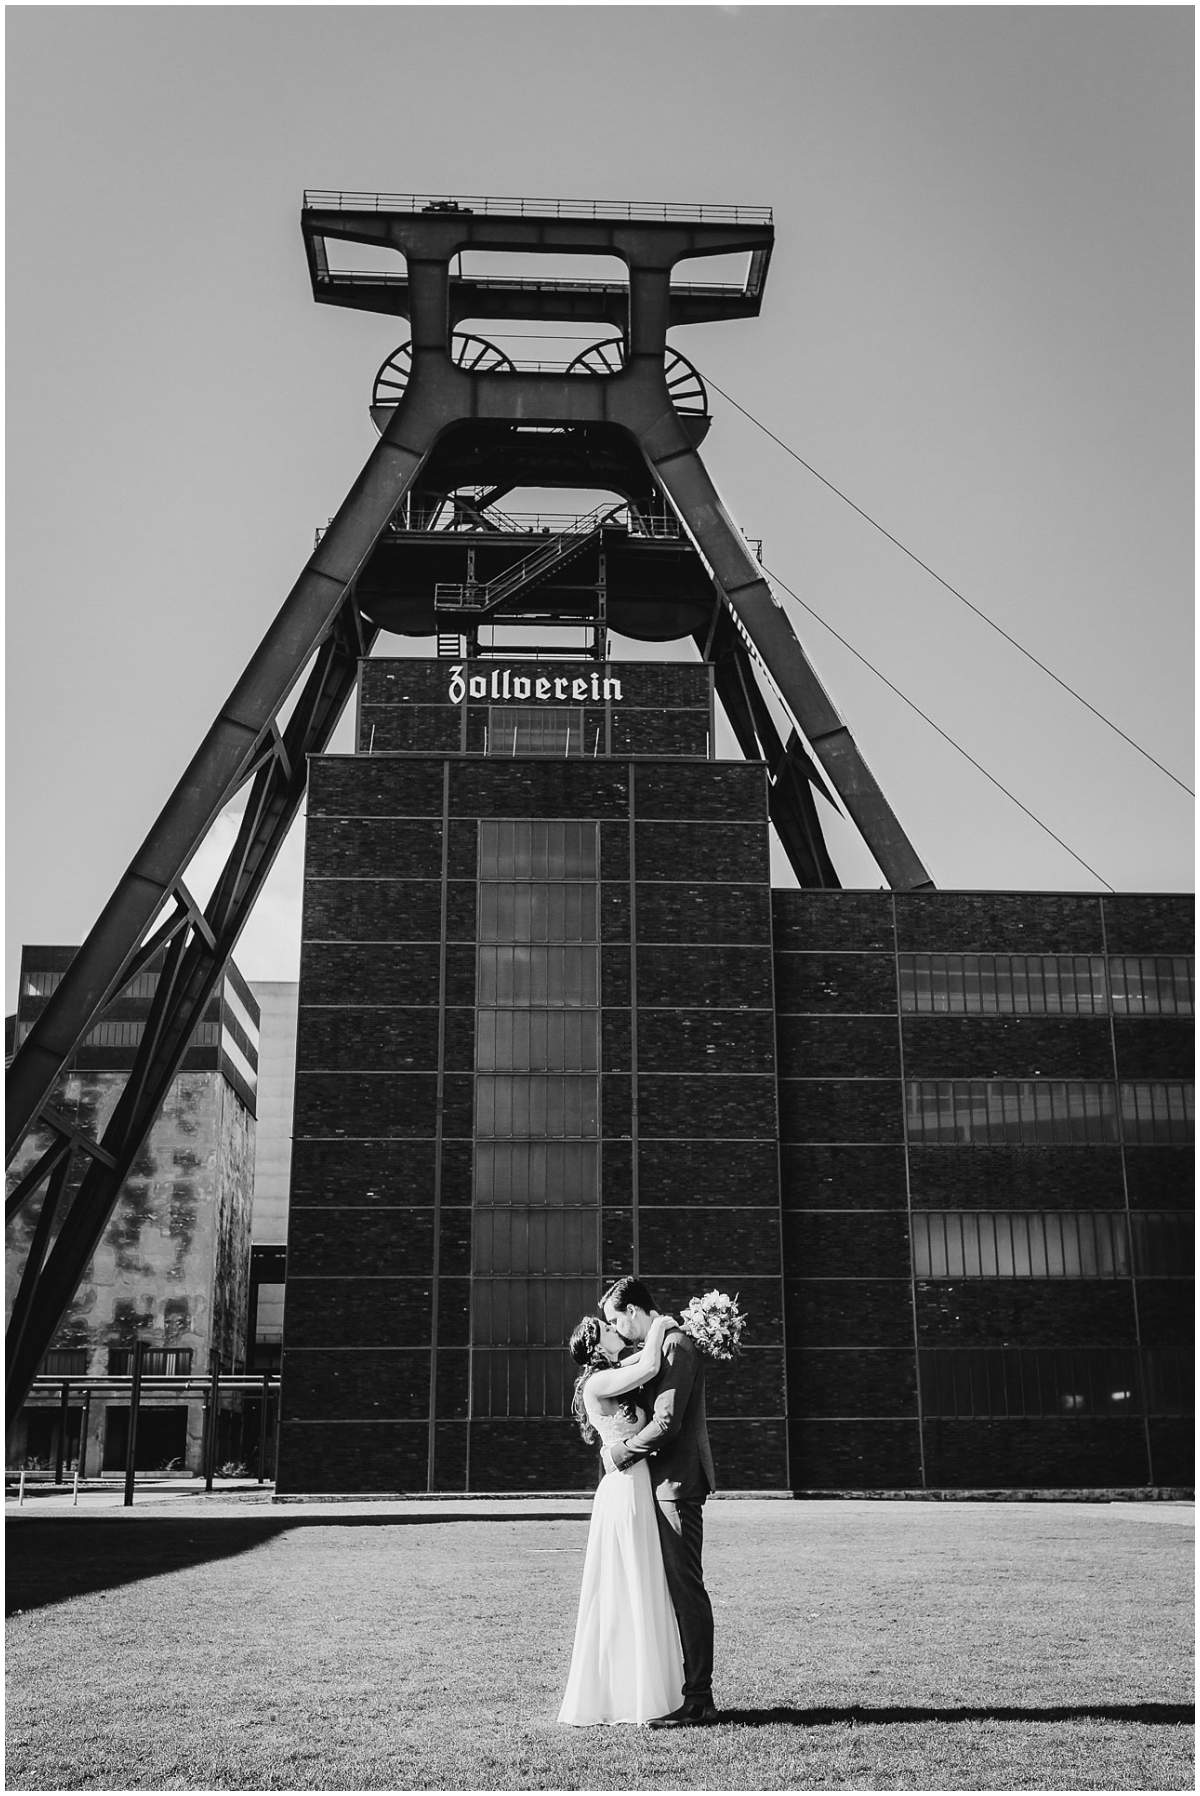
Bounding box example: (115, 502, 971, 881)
(5, 5, 1195, 1009)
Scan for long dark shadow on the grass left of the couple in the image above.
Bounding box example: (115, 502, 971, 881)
(4, 1509, 589, 1615)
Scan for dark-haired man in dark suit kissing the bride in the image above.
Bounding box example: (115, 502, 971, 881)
(600, 1279, 717, 1728)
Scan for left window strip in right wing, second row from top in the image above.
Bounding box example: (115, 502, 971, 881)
(907, 1079, 1117, 1146)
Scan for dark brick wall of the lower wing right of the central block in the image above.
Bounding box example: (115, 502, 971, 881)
(772, 891, 1193, 1489)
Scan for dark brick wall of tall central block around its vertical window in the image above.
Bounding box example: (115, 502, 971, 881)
(278, 663, 789, 1491)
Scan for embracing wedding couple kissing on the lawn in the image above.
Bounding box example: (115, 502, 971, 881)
(559, 1277, 717, 1728)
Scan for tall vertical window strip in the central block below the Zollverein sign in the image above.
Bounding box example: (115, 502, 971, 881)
(471, 815, 600, 1415)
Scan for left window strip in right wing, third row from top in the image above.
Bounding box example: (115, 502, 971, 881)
(913, 1211, 1130, 1279)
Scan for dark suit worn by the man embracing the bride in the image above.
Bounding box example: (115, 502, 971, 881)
(622, 1329, 717, 1703)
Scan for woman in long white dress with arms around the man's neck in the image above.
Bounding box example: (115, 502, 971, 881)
(559, 1316, 683, 1728)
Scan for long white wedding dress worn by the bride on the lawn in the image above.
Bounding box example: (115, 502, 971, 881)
(559, 1413, 683, 1728)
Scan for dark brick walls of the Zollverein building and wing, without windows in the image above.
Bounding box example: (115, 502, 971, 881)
(278, 661, 1191, 1492)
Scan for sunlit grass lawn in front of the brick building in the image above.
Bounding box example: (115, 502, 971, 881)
(5, 1500, 1193, 1791)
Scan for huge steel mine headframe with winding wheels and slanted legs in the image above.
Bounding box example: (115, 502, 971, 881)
(7, 192, 931, 1415)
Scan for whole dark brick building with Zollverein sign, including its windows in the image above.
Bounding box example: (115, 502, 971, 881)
(278, 659, 1193, 1492)
